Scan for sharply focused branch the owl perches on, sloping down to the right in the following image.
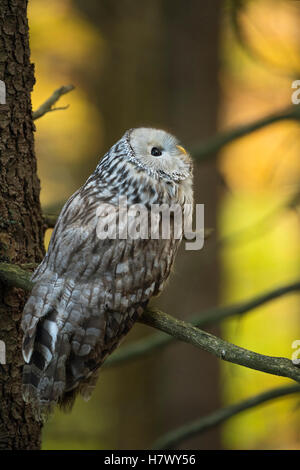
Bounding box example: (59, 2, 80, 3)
(0, 263, 300, 382)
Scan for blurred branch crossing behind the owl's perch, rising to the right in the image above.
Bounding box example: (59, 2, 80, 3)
(104, 281, 300, 367)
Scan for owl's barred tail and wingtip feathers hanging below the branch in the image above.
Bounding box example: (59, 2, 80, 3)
(22, 279, 106, 420)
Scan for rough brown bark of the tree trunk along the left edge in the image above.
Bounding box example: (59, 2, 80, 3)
(0, 0, 43, 449)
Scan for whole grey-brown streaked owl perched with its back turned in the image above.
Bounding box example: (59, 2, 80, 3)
(21, 128, 193, 419)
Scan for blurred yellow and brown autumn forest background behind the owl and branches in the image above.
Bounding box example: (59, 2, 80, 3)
(29, 0, 300, 449)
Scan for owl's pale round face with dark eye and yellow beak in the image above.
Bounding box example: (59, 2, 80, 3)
(125, 127, 192, 181)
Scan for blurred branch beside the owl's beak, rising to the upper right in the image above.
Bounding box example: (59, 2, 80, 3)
(191, 106, 300, 161)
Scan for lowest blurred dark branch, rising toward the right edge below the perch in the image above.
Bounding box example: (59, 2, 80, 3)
(152, 385, 300, 450)
